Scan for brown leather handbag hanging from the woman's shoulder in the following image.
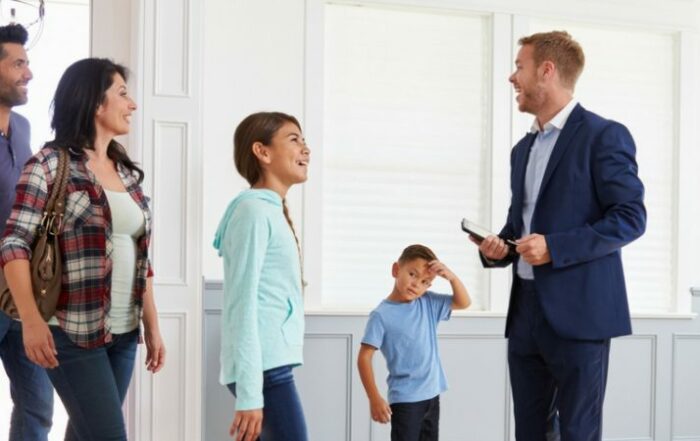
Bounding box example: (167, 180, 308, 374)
(0, 148, 70, 321)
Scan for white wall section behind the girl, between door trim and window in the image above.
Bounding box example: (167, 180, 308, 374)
(202, 0, 304, 278)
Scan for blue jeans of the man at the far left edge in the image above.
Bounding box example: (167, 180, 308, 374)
(0, 311, 53, 441)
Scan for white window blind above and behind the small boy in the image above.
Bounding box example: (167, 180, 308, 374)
(321, 4, 491, 309)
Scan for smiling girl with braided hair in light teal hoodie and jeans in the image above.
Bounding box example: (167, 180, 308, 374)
(214, 112, 310, 441)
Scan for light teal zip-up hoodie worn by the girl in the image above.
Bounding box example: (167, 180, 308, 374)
(214, 189, 304, 410)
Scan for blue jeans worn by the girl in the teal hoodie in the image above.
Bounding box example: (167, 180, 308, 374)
(228, 366, 308, 441)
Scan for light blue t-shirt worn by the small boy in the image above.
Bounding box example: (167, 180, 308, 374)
(362, 291, 452, 404)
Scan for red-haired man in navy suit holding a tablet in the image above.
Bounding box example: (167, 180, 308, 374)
(472, 32, 646, 441)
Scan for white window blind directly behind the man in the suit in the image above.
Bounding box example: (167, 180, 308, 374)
(530, 20, 678, 312)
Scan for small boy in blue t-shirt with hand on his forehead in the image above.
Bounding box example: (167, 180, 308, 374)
(357, 245, 471, 441)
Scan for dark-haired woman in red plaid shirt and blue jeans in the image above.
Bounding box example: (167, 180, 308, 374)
(0, 58, 165, 441)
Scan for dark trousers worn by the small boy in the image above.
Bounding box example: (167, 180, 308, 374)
(391, 395, 440, 441)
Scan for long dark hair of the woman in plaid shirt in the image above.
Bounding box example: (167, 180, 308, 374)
(45, 58, 143, 183)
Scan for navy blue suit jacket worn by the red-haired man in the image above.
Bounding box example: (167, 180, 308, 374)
(484, 105, 646, 340)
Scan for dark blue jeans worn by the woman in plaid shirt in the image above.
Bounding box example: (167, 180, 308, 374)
(46, 326, 138, 441)
